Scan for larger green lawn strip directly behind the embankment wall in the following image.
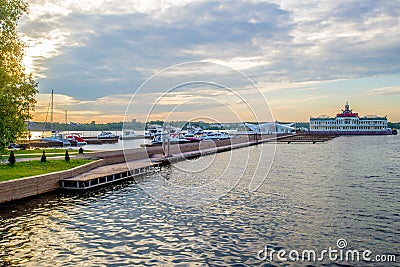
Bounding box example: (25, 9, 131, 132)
(0, 159, 93, 182)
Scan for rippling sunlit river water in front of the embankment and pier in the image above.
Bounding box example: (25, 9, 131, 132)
(0, 136, 400, 266)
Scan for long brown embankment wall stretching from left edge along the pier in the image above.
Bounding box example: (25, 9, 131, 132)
(0, 136, 273, 203)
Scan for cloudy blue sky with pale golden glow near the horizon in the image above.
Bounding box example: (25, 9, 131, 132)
(19, 0, 400, 123)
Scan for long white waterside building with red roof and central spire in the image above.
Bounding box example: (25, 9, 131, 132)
(310, 102, 392, 135)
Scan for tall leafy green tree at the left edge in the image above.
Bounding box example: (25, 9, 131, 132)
(0, 0, 38, 152)
